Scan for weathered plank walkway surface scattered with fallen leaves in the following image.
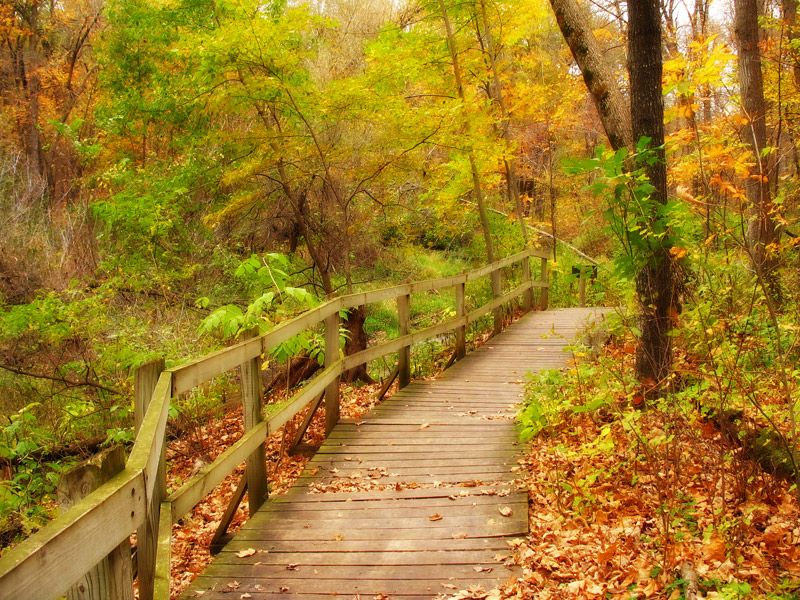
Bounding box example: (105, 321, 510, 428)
(184, 308, 603, 600)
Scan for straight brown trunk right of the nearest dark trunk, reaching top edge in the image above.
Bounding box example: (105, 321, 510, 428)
(733, 0, 775, 279)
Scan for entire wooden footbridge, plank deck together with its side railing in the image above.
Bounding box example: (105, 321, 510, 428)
(0, 251, 608, 600)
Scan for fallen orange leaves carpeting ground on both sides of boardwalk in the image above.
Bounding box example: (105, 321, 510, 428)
(159, 338, 800, 600)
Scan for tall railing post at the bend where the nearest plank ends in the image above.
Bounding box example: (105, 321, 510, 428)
(133, 358, 167, 600)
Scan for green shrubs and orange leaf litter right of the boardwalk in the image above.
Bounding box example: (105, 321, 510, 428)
(520, 300, 800, 600)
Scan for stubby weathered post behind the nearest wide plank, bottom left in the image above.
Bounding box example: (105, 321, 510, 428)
(58, 446, 133, 600)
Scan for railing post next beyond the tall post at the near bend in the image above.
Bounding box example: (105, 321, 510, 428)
(240, 329, 268, 510)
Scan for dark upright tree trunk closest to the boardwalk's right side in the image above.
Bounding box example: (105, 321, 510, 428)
(628, 0, 678, 386)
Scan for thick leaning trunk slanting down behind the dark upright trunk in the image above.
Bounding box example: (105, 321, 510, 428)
(550, 0, 634, 150)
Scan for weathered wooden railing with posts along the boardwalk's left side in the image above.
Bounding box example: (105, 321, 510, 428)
(0, 251, 548, 600)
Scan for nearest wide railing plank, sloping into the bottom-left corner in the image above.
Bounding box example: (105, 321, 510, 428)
(0, 468, 146, 600)
